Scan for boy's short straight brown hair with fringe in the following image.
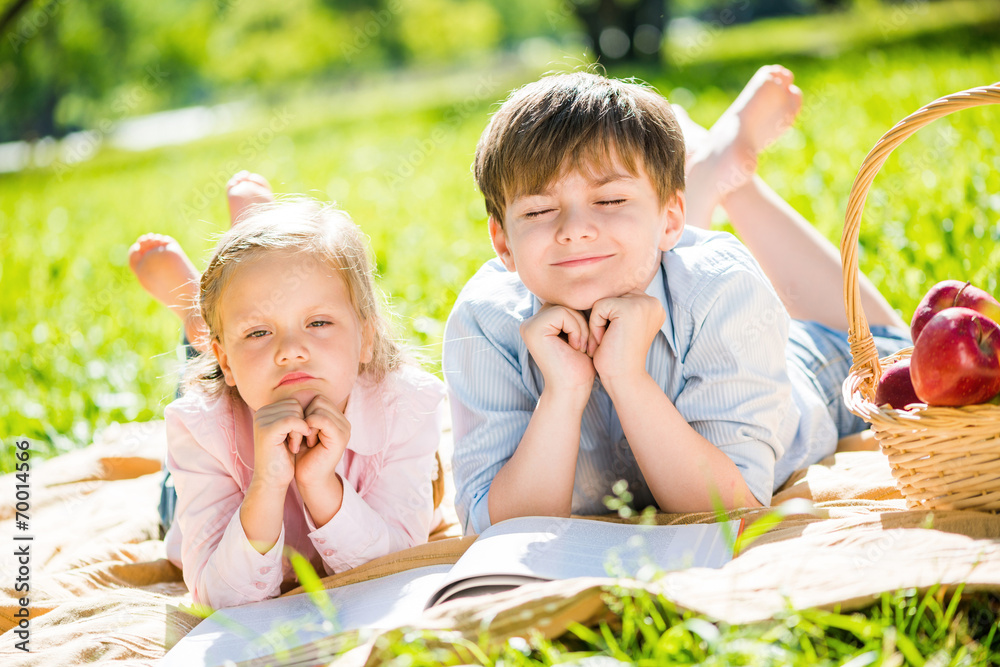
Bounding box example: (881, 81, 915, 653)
(473, 72, 684, 226)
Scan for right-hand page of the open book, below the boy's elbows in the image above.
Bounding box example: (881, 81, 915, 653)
(428, 517, 739, 606)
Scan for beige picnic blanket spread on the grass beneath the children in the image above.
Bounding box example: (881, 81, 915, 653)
(0, 422, 1000, 666)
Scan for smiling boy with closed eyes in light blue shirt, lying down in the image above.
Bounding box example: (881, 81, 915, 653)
(443, 66, 908, 533)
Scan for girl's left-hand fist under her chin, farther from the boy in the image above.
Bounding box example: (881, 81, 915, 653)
(251, 398, 310, 489)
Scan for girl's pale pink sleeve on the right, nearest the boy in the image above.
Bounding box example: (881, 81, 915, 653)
(305, 375, 445, 574)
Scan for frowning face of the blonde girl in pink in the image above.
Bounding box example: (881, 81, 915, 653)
(212, 251, 372, 411)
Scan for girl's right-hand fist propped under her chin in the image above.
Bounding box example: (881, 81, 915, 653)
(295, 395, 351, 491)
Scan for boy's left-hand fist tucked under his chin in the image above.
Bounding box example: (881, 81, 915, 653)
(521, 304, 596, 397)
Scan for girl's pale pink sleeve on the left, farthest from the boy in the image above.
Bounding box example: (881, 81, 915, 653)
(165, 399, 285, 609)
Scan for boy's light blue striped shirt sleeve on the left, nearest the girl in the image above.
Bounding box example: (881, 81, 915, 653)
(442, 297, 538, 534)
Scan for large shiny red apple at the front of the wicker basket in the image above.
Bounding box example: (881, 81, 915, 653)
(910, 308, 1000, 406)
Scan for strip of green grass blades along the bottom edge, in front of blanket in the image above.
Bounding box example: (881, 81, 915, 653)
(474, 588, 1000, 667)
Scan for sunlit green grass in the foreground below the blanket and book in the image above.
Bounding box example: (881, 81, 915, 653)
(276, 587, 1000, 667)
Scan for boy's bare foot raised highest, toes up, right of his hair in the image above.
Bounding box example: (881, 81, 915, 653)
(686, 65, 802, 228)
